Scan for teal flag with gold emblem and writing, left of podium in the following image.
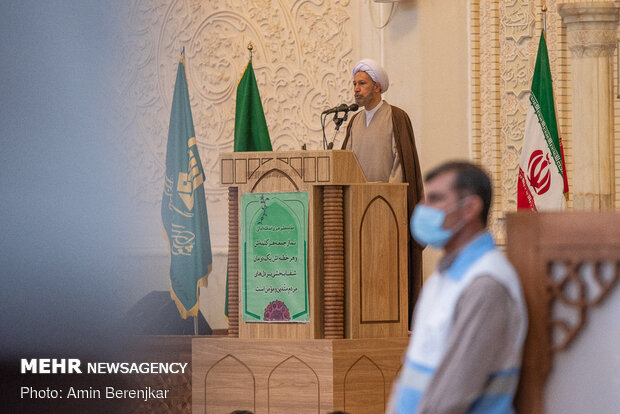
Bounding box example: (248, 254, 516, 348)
(161, 57, 213, 319)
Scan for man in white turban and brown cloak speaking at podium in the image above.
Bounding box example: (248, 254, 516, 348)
(342, 59, 423, 324)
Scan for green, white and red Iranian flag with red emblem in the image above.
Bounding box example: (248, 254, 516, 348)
(517, 30, 568, 211)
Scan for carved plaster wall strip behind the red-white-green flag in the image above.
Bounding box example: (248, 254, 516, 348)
(470, 0, 572, 243)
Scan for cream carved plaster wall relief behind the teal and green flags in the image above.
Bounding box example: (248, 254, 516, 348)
(124, 0, 352, 210)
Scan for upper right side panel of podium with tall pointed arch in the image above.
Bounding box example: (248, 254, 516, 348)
(345, 184, 409, 338)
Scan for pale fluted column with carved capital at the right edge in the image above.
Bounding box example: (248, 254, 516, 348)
(558, 1, 618, 210)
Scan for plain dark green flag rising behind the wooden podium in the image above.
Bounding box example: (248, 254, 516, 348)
(235, 61, 272, 152)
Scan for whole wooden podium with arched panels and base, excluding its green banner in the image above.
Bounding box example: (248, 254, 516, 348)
(192, 151, 408, 414)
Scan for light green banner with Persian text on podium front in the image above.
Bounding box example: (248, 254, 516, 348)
(241, 192, 310, 322)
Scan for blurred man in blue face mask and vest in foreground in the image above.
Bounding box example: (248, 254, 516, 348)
(388, 162, 527, 414)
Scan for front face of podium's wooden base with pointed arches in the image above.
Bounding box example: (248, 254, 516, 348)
(192, 338, 333, 414)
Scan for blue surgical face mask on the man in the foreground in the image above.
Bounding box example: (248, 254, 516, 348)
(409, 199, 465, 249)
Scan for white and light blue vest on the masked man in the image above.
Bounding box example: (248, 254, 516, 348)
(393, 233, 527, 414)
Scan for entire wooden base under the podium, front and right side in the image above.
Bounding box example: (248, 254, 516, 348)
(192, 337, 408, 414)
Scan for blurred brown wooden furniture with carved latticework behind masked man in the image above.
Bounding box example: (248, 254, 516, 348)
(507, 213, 620, 414)
